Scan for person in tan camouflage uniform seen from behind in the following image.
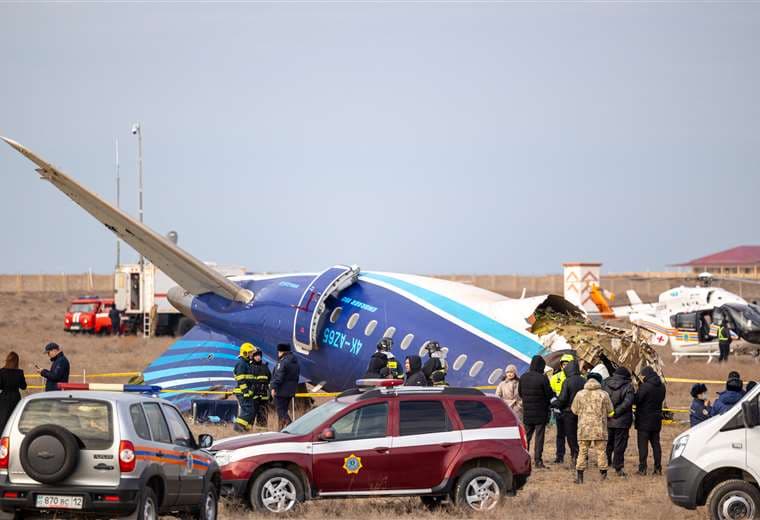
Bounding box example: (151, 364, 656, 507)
(571, 378, 614, 484)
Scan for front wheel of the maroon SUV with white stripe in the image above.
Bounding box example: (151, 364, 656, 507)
(249, 468, 304, 514)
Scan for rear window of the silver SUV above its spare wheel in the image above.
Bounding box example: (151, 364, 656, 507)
(18, 398, 113, 450)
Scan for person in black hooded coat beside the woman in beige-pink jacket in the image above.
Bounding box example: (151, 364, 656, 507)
(517, 356, 554, 468)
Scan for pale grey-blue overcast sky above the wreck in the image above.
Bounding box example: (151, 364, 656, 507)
(0, 2, 760, 273)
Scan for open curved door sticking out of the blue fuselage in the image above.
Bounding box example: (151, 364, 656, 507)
(293, 265, 360, 354)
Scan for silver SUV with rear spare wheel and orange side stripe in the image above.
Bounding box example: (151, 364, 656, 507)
(0, 391, 220, 520)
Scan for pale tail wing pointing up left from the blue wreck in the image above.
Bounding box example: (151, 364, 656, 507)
(0, 136, 253, 303)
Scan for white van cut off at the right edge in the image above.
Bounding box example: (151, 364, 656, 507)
(667, 385, 760, 520)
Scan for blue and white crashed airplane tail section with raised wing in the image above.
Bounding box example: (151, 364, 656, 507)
(5, 133, 600, 401)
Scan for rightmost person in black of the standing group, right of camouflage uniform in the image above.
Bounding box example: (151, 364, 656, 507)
(634, 367, 665, 475)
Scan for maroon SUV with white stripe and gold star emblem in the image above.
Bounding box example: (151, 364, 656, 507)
(212, 380, 531, 513)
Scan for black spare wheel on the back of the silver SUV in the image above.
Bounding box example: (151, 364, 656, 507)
(20, 424, 79, 484)
